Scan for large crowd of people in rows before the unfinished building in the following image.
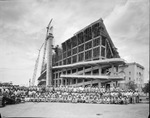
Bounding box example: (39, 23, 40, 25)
(0, 86, 139, 104)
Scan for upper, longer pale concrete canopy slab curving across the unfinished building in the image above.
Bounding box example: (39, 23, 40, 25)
(52, 58, 125, 70)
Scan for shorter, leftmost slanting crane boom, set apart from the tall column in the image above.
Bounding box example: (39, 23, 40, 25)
(32, 43, 44, 86)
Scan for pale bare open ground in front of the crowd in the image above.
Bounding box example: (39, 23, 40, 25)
(0, 102, 149, 118)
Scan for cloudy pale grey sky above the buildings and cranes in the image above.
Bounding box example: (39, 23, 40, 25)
(0, 0, 150, 86)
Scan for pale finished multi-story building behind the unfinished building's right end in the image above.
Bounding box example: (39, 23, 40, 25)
(119, 62, 144, 91)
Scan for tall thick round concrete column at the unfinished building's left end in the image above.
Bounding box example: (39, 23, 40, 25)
(46, 33, 53, 86)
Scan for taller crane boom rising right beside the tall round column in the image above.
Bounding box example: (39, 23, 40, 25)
(41, 19, 53, 74)
